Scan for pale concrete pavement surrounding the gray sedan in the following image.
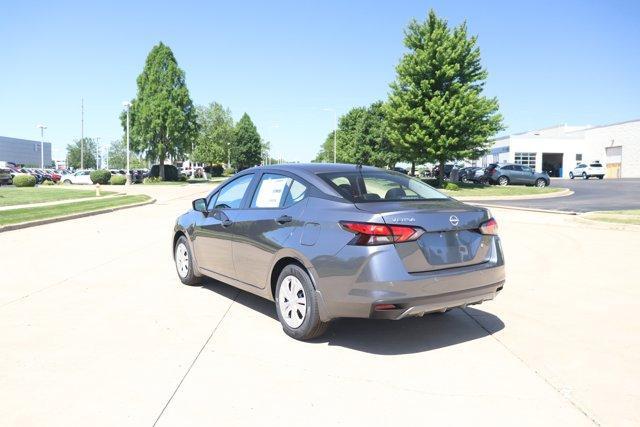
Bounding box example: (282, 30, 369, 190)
(0, 186, 640, 426)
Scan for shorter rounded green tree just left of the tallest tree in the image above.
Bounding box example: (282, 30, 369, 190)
(316, 101, 400, 167)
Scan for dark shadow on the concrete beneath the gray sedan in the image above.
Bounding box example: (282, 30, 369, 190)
(202, 279, 505, 355)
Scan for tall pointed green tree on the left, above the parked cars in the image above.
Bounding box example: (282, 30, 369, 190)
(120, 43, 197, 178)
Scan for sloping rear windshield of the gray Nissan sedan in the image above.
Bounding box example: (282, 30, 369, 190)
(318, 170, 447, 203)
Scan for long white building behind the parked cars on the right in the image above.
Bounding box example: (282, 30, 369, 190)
(481, 120, 640, 178)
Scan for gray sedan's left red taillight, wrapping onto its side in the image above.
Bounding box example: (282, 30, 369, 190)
(340, 221, 424, 246)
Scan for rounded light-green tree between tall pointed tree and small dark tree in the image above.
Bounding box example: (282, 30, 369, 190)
(193, 102, 234, 164)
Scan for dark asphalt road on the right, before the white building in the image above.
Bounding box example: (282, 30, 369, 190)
(470, 178, 640, 212)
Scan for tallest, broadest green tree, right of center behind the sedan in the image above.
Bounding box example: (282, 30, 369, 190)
(385, 10, 503, 183)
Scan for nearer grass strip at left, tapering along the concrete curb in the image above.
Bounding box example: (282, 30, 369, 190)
(0, 195, 150, 225)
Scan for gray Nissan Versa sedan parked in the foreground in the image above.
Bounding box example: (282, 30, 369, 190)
(173, 164, 505, 339)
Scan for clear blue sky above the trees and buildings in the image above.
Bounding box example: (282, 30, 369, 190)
(0, 0, 640, 161)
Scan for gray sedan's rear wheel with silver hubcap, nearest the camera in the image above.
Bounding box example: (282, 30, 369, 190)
(274, 264, 329, 340)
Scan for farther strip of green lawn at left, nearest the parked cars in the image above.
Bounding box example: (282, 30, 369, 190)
(0, 187, 114, 206)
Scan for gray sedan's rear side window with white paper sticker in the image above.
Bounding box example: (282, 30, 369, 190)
(251, 173, 307, 208)
